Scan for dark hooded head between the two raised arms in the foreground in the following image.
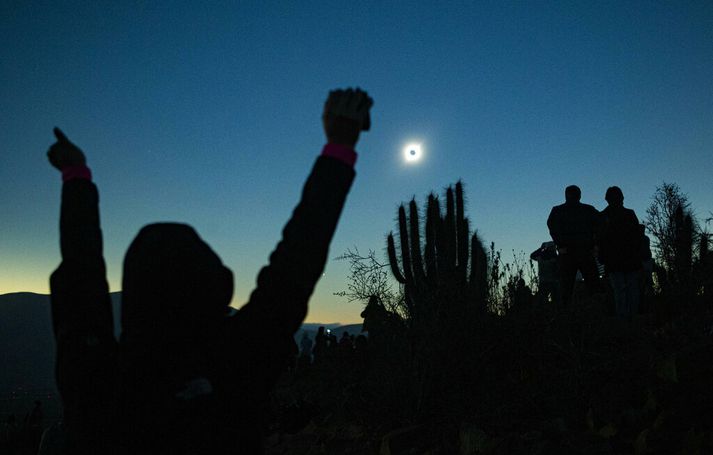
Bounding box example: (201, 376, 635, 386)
(121, 223, 233, 341)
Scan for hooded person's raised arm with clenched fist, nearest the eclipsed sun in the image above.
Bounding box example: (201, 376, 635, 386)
(237, 89, 373, 338)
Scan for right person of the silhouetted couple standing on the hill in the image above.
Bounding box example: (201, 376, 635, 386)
(599, 186, 643, 321)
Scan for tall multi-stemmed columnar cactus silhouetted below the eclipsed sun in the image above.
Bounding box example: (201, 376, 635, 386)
(387, 182, 488, 321)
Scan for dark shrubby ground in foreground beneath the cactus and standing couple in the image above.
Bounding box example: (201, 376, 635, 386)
(267, 297, 713, 454)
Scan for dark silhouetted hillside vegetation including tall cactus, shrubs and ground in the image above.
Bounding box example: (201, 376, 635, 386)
(268, 184, 713, 454)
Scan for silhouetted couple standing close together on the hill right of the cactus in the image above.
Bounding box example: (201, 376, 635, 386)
(547, 185, 643, 319)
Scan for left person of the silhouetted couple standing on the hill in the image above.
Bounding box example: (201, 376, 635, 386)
(547, 185, 599, 305)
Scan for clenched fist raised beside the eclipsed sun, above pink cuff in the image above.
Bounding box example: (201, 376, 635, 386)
(322, 88, 374, 148)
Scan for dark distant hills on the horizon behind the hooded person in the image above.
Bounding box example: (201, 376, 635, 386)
(0, 292, 361, 394)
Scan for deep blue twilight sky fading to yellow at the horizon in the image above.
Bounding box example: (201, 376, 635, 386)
(0, 0, 713, 322)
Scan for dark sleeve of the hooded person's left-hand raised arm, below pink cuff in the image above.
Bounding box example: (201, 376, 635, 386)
(50, 179, 116, 451)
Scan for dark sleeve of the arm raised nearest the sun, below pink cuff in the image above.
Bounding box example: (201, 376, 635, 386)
(230, 156, 355, 378)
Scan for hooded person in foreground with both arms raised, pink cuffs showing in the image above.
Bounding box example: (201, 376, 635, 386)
(48, 89, 372, 454)
